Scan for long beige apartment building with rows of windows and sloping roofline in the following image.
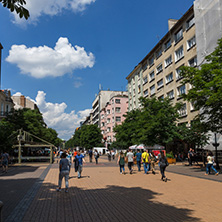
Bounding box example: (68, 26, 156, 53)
(126, 6, 197, 123)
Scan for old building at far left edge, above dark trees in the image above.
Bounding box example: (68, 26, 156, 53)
(0, 90, 14, 120)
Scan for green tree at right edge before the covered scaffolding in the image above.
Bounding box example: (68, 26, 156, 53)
(181, 38, 222, 133)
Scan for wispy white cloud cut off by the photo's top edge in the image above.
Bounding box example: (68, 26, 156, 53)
(14, 0, 96, 24)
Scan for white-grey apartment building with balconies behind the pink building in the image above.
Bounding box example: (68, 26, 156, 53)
(92, 90, 126, 127)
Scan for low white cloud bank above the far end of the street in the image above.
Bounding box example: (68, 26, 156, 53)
(35, 91, 91, 139)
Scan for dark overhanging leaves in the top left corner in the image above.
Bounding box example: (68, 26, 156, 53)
(0, 0, 30, 20)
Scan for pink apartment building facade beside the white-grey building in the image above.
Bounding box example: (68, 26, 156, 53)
(100, 93, 128, 144)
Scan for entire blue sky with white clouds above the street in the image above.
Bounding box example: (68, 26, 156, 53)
(0, 0, 193, 139)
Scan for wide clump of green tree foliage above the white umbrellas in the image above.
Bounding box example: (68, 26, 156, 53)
(114, 98, 180, 148)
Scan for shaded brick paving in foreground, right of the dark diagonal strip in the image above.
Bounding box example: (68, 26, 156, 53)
(23, 184, 201, 222)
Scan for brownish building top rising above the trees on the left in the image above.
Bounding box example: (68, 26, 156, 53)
(12, 95, 39, 110)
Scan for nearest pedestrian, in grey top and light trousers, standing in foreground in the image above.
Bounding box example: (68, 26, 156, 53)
(57, 152, 70, 193)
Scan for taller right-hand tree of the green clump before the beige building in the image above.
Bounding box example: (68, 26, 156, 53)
(136, 98, 181, 145)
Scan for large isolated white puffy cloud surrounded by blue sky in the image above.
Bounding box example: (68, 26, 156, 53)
(6, 37, 95, 78)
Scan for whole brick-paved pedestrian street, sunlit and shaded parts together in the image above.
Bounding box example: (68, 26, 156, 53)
(0, 157, 222, 222)
